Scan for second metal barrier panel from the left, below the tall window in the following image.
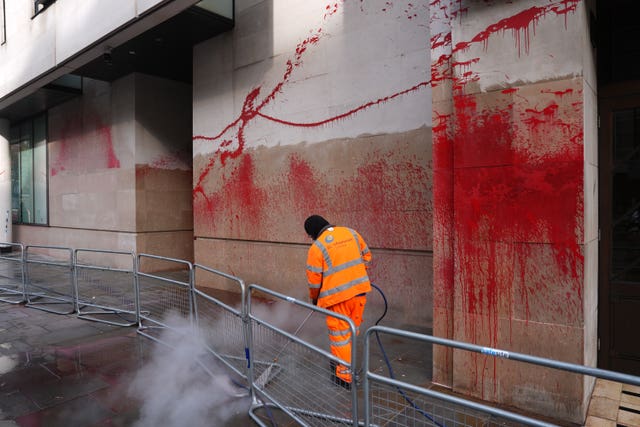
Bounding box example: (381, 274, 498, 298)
(24, 245, 76, 314)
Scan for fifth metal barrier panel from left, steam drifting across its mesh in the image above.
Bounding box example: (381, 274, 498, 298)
(193, 264, 248, 385)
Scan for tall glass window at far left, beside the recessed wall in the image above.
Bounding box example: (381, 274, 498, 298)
(10, 115, 48, 224)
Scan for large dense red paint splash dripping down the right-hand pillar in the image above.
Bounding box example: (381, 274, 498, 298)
(450, 89, 584, 397)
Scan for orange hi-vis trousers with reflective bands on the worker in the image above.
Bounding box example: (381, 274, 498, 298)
(327, 295, 367, 383)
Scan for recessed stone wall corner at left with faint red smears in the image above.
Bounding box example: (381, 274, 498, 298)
(14, 74, 193, 268)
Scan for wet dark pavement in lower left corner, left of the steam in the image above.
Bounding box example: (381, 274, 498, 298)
(0, 302, 255, 427)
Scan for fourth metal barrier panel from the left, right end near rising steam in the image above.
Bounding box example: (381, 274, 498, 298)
(136, 254, 193, 344)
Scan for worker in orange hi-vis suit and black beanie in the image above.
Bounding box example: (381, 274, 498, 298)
(304, 215, 371, 389)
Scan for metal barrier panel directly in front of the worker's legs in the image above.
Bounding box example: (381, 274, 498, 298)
(247, 285, 358, 426)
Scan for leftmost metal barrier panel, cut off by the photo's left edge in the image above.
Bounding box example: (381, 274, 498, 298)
(0, 243, 26, 304)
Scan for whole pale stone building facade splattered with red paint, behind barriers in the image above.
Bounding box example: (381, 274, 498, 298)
(0, 0, 640, 422)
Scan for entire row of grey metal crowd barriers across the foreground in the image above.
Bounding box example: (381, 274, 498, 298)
(0, 243, 640, 427)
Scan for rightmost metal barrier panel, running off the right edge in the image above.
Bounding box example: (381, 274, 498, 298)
(363, 326, 640, 427)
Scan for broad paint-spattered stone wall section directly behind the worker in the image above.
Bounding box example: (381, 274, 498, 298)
(193, 0, 432, 327)
